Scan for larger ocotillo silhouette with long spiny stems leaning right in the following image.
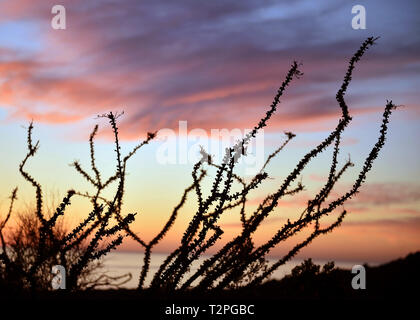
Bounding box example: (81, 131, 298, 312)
(146, 37, 396, 290)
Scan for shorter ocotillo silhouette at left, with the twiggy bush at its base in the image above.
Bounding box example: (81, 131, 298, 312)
(0, 112, 154, 290)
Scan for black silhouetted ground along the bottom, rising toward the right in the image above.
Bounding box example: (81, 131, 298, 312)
(0, 252, 420, 320)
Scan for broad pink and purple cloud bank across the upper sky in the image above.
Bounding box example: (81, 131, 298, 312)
(0, 0, 418, 139)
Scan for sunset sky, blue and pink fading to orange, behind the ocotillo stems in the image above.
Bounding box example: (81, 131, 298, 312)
(0, 0, 420, 262)
